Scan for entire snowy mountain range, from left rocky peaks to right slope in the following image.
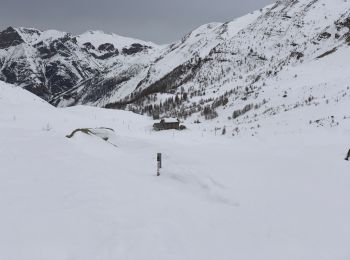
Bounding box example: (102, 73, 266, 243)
(0, 0, 350, 125)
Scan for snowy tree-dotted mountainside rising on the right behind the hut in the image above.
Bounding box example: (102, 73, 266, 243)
(111, 0, 350, 121)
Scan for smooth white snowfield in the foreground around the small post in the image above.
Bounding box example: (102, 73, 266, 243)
(0, 79, 350, 260)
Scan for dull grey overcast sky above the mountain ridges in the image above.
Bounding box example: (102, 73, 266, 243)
(0, 0, 275, 43)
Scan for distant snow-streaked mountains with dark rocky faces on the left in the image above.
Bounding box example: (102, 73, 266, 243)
(0, 27, 160, 100)
